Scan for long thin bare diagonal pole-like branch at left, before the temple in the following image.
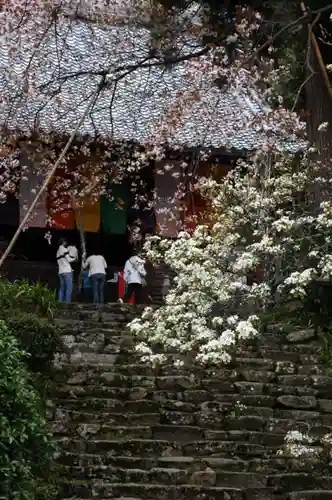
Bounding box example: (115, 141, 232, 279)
(0, 76, 105, 268)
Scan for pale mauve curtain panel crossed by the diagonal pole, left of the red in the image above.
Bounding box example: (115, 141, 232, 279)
(19, 156, 47, 228)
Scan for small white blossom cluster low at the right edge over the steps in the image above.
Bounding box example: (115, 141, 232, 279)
(278, 430, 332, 464)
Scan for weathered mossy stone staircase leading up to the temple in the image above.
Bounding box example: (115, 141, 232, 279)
(50, 305, 332, 500)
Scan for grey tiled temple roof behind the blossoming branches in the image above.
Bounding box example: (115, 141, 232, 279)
(0, 22, 295, 150)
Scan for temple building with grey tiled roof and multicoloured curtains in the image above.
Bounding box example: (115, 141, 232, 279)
(0, 16, 296, 296)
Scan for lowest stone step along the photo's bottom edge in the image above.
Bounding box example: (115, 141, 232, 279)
(59, 481, 244, 500)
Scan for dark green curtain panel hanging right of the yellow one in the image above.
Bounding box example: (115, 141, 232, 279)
(100, 184, 129, 234)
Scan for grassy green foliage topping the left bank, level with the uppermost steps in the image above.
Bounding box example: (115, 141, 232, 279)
(0, 280, 57, 316)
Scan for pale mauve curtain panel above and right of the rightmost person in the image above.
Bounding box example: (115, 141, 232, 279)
(155, 161, 181, 238)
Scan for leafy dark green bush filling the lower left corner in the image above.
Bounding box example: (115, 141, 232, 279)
(0, 321, 55, 500)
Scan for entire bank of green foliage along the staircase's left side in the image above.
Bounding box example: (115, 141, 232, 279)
(0, 280, 61, 500)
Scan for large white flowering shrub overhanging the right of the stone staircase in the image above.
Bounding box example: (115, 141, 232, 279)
(130, 149, 332, 366)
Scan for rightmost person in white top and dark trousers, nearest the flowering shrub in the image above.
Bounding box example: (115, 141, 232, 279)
(119, 255, 146, 304)
